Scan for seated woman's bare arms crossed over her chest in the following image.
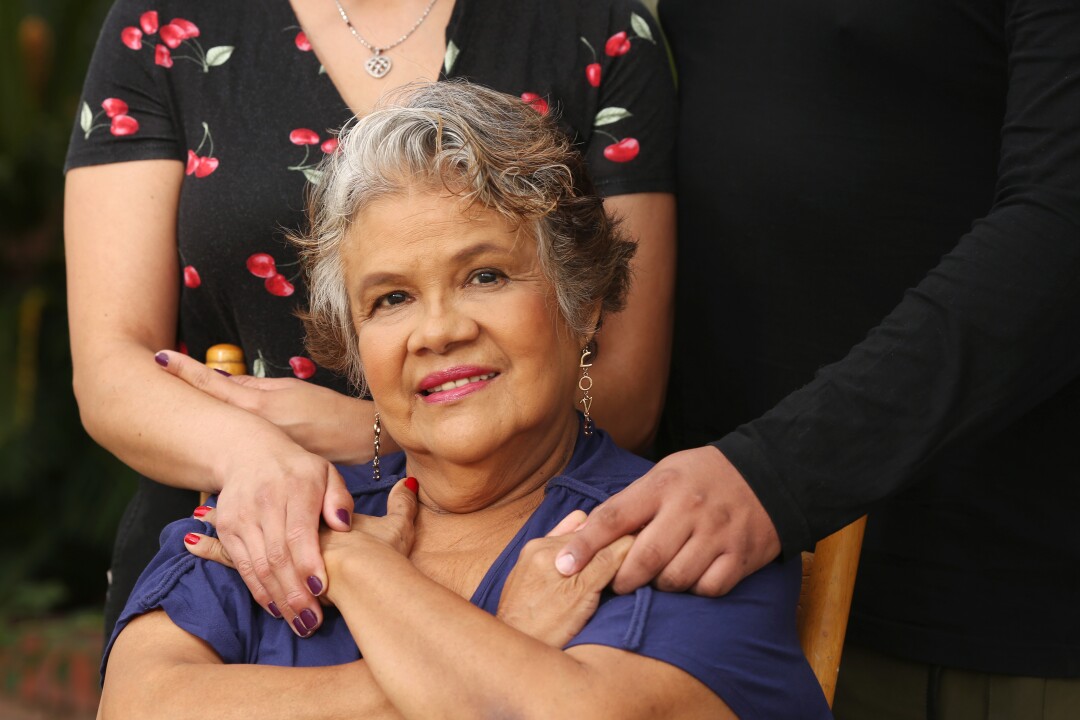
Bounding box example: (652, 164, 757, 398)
(99, 488, 733, 719)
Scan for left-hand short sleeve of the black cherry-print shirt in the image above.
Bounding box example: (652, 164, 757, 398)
(65, 0, 184, 171)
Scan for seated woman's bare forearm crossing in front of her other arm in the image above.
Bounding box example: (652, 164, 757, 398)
(328, 545, 626, 718)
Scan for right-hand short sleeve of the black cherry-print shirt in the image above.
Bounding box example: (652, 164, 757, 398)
(582, 2, 676, 196)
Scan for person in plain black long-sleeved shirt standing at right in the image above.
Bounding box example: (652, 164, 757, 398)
(563, 0, 1080, 717)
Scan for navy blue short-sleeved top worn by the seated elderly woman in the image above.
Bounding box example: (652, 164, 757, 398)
(102, 432, 832, 718)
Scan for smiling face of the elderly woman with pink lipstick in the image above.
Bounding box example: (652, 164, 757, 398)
(342, 189, 583, 472)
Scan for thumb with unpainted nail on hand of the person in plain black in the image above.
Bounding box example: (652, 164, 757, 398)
(555, 481, 658, 575)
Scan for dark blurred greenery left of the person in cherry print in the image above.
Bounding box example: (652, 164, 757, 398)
(0, 0, 135, 720)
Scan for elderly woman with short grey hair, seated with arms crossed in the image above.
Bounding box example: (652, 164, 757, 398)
(102, 83, 828, 719)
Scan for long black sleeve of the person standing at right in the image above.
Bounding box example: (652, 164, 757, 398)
(714, 0, 1080, 554)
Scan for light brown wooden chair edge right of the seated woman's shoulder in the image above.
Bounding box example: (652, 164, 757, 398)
(798, 516, 866, 707)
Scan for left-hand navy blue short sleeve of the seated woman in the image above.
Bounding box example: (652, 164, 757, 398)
(102, 518, 261, 678)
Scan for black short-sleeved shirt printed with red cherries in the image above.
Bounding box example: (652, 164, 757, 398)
(67, 0, 675, 392)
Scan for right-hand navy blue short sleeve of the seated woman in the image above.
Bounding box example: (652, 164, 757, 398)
(567, 561, 831, 719)
